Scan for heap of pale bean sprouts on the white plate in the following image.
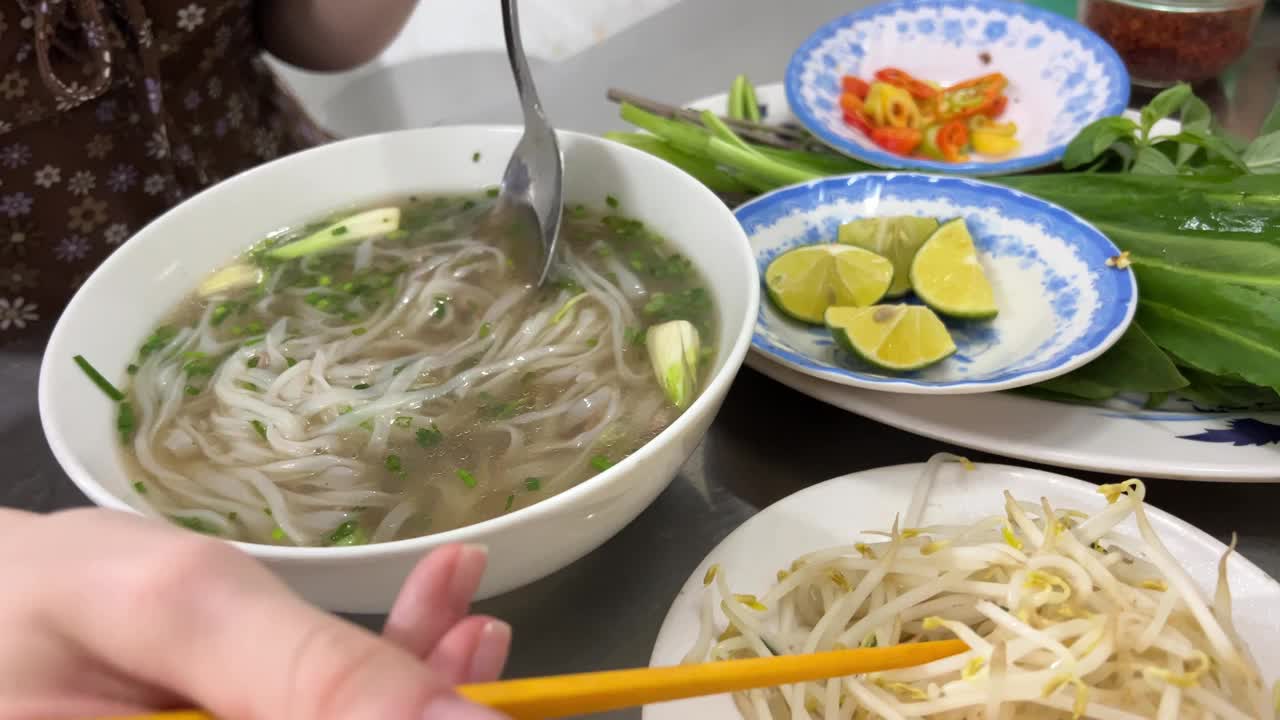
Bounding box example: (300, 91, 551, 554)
(685, 456, 1280, 720)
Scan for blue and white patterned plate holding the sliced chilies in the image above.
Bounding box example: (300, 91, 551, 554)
(786, 0, 1129, 174)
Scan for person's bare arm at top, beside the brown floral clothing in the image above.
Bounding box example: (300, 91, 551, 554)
(257, 0, 417, 72)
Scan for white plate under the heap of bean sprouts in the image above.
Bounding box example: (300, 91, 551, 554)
(643, 464, 1280, 720)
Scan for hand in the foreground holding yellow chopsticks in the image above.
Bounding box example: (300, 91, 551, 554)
(0, 509, 511, 720)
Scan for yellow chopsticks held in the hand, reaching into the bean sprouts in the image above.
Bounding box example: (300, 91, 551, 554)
(122, 641, 969, 720)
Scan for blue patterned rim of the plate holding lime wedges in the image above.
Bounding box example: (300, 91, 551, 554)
(733, 172, 1138, 392)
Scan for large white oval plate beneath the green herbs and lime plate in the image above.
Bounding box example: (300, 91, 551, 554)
(689, 83, 1280, 482)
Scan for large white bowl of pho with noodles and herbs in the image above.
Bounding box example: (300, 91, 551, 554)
(40, 127, 759, 612)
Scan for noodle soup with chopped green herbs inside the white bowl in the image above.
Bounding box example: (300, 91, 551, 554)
(119, 197, 716, 546)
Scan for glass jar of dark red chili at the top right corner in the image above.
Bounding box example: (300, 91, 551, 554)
(1079, 0, 1265, 87)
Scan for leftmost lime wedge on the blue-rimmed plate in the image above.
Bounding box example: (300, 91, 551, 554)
(764, 245, 893, 324)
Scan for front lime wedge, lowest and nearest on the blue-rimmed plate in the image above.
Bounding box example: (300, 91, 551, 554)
(826, 305, 956, 373)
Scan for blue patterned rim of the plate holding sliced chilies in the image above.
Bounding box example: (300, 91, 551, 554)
(785, 0, 1129, 176)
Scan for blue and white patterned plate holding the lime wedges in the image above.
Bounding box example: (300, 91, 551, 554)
(735, 173, 1138, 395)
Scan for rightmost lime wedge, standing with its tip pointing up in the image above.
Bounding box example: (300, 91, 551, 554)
(911, 218, 998, 318)
